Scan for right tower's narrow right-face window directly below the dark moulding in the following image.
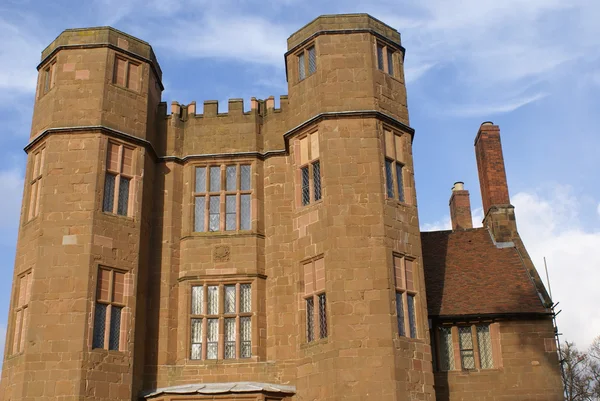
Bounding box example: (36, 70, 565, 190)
(384, 129, 406, 202)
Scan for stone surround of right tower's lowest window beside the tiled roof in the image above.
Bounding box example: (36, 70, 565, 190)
(392, 252, 423, 340)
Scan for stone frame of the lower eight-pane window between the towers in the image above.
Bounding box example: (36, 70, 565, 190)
(186, 279, 253, 363)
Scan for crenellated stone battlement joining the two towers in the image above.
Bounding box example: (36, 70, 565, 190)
(168, 95, 288, 121)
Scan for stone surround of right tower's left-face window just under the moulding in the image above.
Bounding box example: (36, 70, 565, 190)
(294, 129, 323, 208)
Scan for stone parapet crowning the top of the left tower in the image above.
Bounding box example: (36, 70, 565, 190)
(38, 26, 162, 81)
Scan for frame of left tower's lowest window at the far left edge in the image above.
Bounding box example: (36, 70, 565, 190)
(6, 269, 33, 356)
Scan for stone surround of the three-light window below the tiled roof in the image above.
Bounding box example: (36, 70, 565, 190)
(431, 321, 502, 373)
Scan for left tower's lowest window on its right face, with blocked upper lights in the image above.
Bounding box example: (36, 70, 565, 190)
(92, 268, 125, 351)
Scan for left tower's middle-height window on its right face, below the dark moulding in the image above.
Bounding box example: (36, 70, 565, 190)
(102, 142, 134, 216)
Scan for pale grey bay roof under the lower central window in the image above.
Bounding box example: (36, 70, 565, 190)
(143, 382, 296, 398)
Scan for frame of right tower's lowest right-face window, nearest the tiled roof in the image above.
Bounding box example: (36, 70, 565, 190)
(392, 253, 422, 340)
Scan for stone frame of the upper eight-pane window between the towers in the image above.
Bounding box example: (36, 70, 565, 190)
(191, 160, 256, 234)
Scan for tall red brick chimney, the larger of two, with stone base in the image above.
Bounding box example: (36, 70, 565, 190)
(475, 121, 517, 242)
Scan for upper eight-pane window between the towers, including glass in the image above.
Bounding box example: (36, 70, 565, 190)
(193, 164, 252, 232)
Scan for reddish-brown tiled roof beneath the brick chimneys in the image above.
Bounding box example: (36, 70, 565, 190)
(421, 228, 546, 316)
